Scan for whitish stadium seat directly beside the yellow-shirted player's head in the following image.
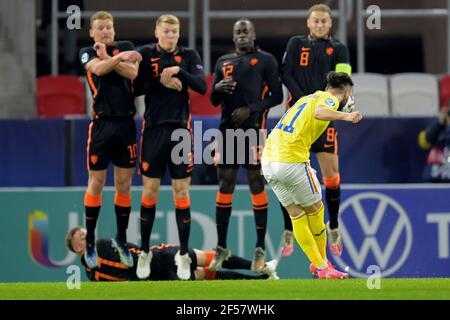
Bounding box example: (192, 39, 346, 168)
(352, 73, 390, 117)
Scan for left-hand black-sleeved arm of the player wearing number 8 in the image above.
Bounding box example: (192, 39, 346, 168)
(281, 38, 305, 101)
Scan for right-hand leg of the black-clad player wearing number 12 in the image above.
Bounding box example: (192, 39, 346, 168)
(247, 166, 268, 272)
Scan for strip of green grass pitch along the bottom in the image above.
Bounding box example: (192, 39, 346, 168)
(0, 278, 450, 300)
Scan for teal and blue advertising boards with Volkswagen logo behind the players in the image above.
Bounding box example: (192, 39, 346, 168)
(0, 184, 450, 282)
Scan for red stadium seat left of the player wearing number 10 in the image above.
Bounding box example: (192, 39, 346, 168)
(36, 76, 86, 118)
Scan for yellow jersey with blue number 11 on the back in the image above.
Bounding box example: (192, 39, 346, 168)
(262, 91, 339, 163)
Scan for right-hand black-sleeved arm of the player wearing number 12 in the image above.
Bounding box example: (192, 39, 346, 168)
(249, 56, 283, 112)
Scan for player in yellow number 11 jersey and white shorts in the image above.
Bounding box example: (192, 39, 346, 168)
(261, 71, 362, 279)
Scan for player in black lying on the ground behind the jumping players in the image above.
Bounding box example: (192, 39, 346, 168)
(66, 227, 279, 281)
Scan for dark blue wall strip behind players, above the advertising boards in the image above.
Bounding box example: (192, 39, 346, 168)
(0, 117, 432, 187)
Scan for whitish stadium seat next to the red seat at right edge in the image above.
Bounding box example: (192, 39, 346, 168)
(391, 73, 439, 117)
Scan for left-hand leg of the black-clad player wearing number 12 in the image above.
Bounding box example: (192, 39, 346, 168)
(209, 165, 237, 271)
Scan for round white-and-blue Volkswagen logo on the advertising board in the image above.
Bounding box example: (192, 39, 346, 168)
(333, 192, 412, 277)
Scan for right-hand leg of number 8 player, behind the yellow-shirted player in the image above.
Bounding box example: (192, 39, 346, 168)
(317, 152, 342, 256)
